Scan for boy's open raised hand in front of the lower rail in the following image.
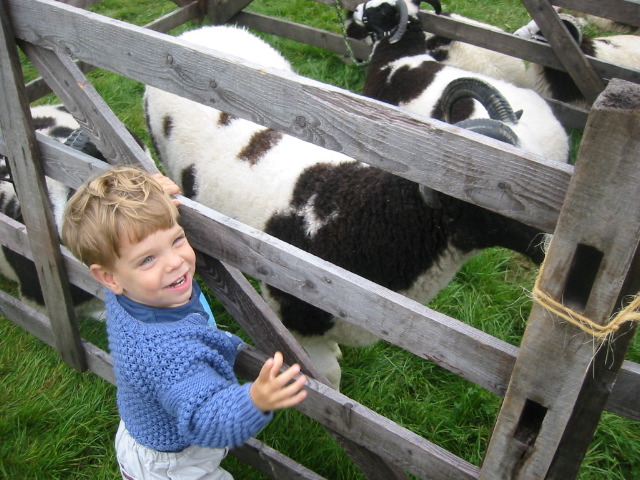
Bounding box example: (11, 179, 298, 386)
(249, 352, 307, 412)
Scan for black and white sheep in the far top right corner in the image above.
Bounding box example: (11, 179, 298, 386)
(514, 13, 640, 108)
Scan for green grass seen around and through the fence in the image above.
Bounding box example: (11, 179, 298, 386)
(0, 0, 640, 480)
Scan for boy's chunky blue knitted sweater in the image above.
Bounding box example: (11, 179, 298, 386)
(105, 290, 273, 452)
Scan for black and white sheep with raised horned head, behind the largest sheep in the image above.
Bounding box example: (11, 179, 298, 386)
(353, 0, 569, 162)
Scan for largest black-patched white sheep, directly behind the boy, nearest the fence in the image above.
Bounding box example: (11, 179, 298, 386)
(144, 26, 556, 386)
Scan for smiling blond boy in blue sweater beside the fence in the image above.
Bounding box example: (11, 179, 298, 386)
(62, 167, 306, 480)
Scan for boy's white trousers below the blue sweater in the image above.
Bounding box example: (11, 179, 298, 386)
(116, 420, 233, 480)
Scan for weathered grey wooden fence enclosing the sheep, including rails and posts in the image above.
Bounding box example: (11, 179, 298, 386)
(0, 0, 640, 480)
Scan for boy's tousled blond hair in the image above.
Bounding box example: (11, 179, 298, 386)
(62, 166, 179, 268)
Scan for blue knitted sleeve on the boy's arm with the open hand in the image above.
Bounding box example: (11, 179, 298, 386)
(160, 362, 273, 448)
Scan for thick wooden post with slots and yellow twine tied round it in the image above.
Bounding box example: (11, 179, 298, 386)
(480, 79, 640, 480)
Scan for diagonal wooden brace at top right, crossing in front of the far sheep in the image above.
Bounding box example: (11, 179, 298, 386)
(522, 0, 605, 103)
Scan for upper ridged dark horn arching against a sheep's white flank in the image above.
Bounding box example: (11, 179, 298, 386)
(441, 77, 518, 124)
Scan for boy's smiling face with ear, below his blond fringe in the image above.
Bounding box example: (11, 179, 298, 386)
(90, 225, 196, 308)
